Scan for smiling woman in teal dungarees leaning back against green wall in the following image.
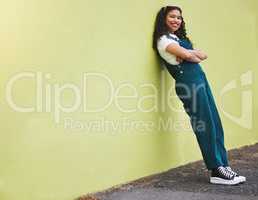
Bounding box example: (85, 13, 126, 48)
(153, 6, 246, 185)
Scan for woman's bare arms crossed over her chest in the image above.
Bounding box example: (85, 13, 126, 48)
(166, 43, 208, 63)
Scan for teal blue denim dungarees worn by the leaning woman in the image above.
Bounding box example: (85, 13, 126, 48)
(164, 36, 228, 170)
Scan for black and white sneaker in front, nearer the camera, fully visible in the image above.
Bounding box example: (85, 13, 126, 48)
(210, 166, 240, 185)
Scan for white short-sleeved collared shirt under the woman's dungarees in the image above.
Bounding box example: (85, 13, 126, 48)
(157, 33, 179, 65)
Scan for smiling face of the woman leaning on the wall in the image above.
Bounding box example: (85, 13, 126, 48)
(166, 10, 182, 33)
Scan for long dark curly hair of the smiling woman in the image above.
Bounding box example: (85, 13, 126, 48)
(152, 6, 192, 56)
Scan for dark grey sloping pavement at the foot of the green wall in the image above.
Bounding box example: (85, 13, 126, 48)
(79, 143, 258, 200)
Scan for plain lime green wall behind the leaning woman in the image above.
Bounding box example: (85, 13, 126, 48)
(0, 0, 258, 200)
